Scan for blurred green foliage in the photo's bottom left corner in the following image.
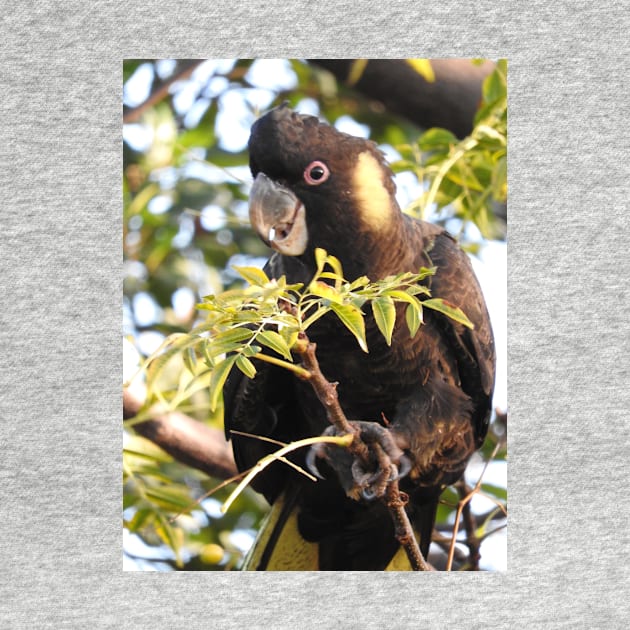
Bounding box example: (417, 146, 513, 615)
(123, 436, 264, 570)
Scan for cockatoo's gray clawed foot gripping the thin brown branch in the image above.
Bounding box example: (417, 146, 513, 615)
(306, 421, 411, 501)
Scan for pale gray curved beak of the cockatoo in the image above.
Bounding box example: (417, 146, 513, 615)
(249, 173, 308, 256)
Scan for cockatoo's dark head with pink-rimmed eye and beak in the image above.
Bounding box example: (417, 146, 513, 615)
(249, 105, 400, 268)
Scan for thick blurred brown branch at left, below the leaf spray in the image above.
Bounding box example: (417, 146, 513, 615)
(123, 389, 238, 479)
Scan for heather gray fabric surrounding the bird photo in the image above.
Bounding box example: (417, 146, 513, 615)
(0, 0, 630, 629)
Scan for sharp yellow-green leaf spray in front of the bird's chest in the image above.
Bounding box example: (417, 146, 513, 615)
(134, 249, 472, 422)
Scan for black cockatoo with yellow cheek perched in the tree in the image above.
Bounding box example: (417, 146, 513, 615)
(224, 105, 495, 570)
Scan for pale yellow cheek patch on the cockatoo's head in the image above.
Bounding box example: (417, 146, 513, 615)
(352, 151, 392, 231)
